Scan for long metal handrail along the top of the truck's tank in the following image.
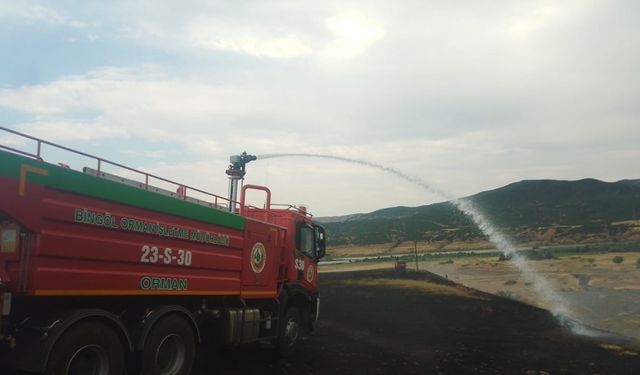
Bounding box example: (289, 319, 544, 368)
(0, 126, 238, 207)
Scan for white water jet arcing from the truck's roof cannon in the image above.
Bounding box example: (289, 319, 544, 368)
(256, 153, 590, 334)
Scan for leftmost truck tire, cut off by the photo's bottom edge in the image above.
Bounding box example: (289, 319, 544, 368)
(46, 322, 125, 375)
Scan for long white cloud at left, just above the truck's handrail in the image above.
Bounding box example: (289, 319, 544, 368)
(0, 67, 267, 118)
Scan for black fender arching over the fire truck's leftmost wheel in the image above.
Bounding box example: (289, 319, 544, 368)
(8, 309, 133, 372)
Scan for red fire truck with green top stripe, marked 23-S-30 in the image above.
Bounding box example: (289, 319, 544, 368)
(0, 128, 325, 375)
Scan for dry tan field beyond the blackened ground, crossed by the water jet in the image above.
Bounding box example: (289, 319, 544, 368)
(416, 253, 640, 340)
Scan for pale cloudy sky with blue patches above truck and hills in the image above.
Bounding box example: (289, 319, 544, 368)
(0, 0, 640, 215)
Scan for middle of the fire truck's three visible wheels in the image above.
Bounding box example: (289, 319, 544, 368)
(140, 315, 196, 375)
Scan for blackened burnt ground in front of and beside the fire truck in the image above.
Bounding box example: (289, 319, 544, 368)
(194, 269, 640, 375)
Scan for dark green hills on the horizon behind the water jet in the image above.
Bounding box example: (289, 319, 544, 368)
(320, 179, 640, 250)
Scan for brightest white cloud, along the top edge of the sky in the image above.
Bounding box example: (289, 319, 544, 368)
(98, 2, 385, 60)
